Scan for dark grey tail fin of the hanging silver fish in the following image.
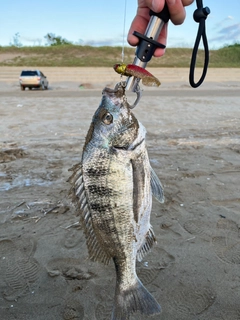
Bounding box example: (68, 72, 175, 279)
(111, 278, 161, 320)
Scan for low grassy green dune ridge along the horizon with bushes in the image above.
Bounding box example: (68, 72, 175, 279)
(0, 43, 240, 68)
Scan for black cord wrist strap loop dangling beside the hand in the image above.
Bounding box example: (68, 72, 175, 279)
(189, 0, 210, 88)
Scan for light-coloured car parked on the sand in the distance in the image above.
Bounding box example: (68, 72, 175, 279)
(19, 70, 48, 90)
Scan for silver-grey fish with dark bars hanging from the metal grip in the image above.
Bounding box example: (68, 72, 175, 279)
(70, 83, 164, 320)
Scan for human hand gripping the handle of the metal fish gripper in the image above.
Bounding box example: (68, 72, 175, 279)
(128, 0, 194, 57)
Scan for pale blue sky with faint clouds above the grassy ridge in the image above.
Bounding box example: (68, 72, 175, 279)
(0, 0, 240, 49)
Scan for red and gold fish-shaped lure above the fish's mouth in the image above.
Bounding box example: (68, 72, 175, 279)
(113, 63, 161, 87)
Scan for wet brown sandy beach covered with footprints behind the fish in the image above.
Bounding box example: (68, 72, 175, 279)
(0, 67, 240, 320)
